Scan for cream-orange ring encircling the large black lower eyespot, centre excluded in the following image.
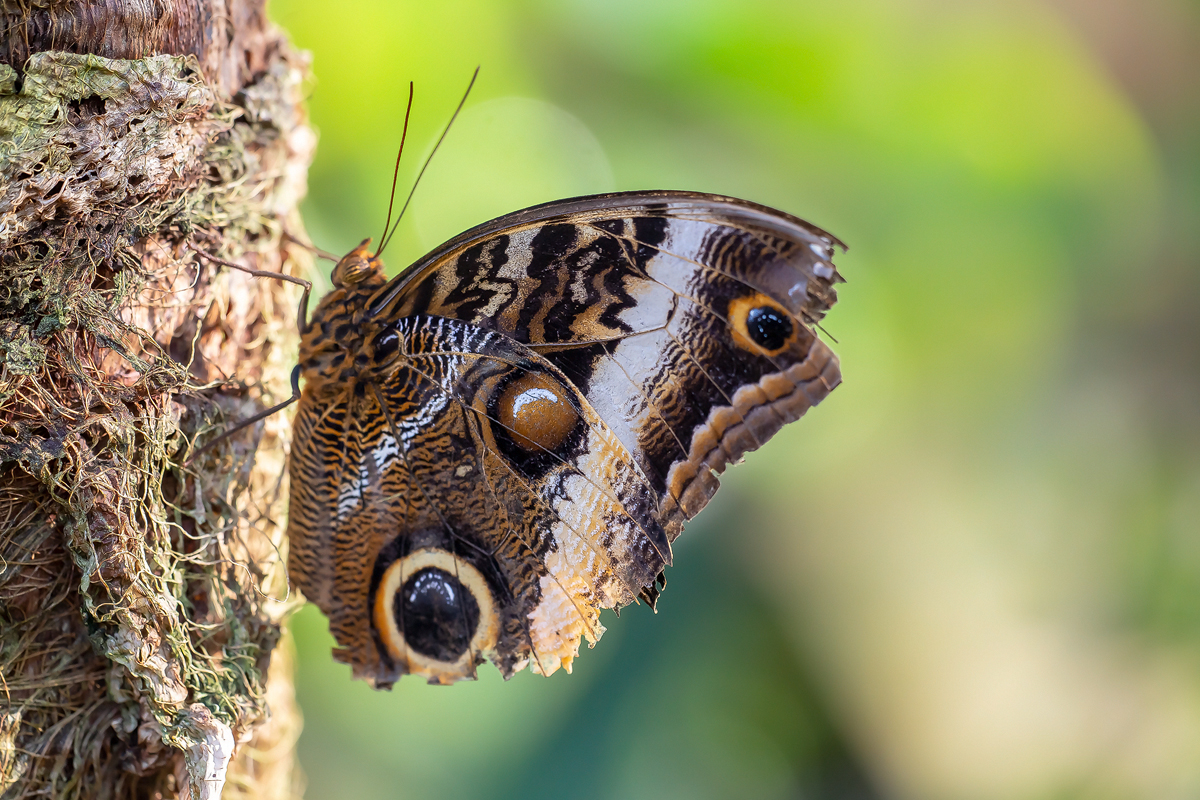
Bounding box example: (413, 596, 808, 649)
(373, 547, 500, 684)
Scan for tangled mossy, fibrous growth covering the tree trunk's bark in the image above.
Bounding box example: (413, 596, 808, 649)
(0, 53, 307, 798)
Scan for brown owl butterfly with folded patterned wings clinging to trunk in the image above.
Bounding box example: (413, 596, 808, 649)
(288, 192, 841, 686)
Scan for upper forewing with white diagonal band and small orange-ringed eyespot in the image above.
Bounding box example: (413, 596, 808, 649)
(371, 192, 841, 541)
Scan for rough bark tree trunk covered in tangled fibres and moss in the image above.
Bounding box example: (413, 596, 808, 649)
(0, 0, 314, 798)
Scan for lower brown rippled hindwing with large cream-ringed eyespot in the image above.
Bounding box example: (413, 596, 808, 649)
(289, 314, 671, 685)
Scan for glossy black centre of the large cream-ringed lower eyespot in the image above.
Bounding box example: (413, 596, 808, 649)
(392, 567, 479, 662)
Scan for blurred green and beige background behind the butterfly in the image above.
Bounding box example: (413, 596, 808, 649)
(271, 0, 1200, 800)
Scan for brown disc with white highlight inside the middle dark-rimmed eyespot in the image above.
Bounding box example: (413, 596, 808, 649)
(496, 372, 580, 453)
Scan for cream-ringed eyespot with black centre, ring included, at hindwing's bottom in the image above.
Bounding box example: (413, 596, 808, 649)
(373, 548, 499, 684)
